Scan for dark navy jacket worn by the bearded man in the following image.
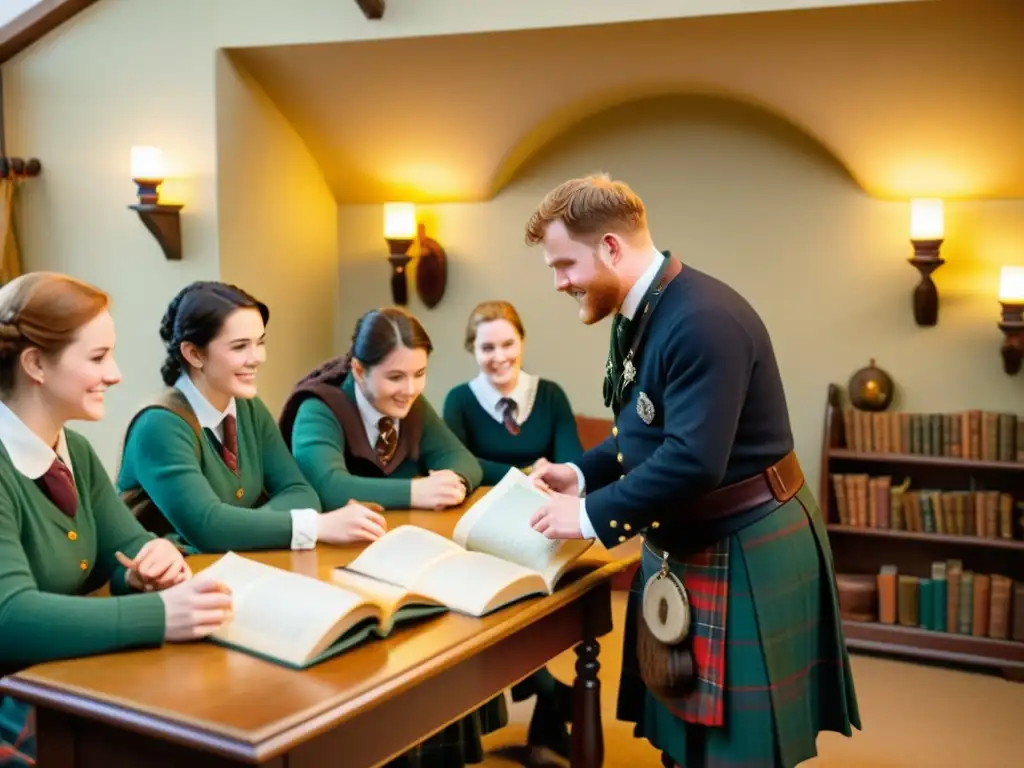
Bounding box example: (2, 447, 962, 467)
(578, 265, 793, 547)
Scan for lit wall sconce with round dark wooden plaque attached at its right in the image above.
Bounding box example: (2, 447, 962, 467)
(384, 203, 447, 309)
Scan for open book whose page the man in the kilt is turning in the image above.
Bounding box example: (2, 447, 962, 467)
(335, 468, 593, 616)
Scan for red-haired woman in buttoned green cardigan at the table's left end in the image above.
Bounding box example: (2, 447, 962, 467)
(0, 272, 231, 766)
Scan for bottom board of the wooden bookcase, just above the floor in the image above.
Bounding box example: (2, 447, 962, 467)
(843, 620, 1024, 677)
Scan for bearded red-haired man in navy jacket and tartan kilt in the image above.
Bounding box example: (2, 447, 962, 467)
(526, 176, 860, 768)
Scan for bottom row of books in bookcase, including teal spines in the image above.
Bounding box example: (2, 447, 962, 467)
(878, 559, 1024, 641)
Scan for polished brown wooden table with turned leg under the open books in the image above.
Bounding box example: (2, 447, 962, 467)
(0, 492, 636, 768)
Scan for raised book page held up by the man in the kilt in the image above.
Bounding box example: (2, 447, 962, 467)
(453, 467, 593, 592)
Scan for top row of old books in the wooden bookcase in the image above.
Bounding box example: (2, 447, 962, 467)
(843, 407, 1024, 462)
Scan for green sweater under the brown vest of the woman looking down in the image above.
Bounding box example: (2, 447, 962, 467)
(292, 376, 483, 509)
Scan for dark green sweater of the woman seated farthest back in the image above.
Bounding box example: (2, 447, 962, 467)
(444, 379, 583, 485)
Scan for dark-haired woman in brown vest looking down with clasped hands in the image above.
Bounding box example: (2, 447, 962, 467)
(281, 307, 508, 768)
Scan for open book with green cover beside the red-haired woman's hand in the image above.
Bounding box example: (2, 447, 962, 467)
(197, 552, 446, 669)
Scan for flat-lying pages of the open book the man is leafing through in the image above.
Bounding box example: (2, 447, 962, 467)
(339, 525, 547, 616)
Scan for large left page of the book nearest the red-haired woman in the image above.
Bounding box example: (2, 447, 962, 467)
(197, 552, 380, 667)
